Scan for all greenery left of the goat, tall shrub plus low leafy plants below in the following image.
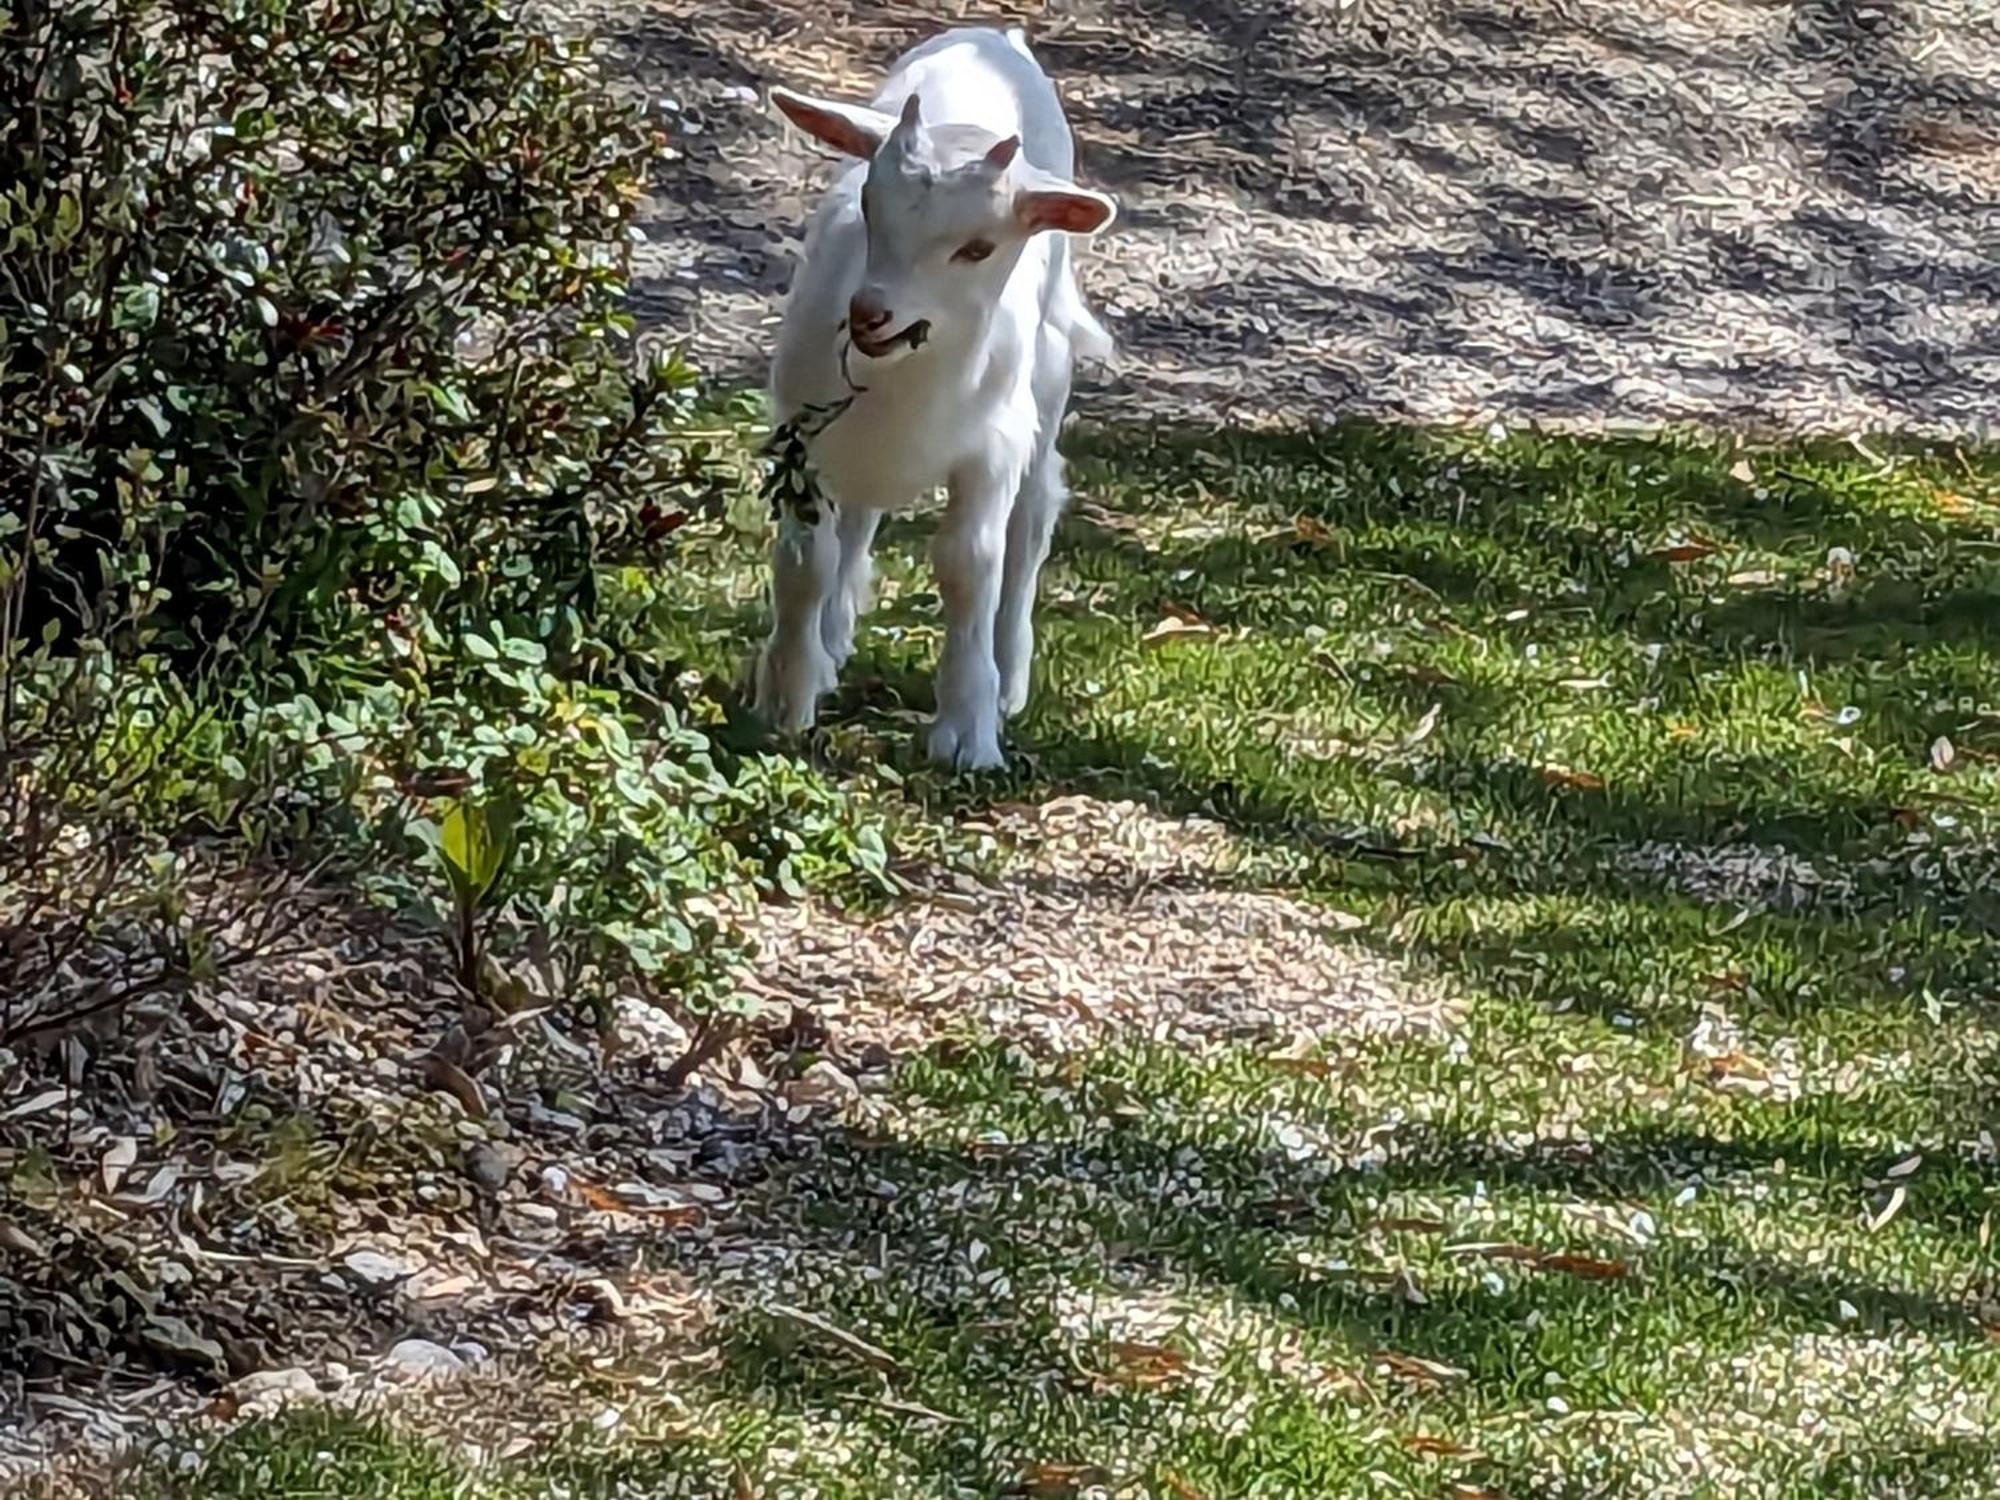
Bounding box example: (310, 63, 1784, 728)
(0, 0, 882, 1040)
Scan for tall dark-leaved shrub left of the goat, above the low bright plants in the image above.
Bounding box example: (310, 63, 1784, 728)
(0, 0, 700, 660)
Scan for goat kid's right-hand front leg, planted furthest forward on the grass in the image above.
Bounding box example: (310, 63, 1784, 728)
(930, 466, 1018, 770)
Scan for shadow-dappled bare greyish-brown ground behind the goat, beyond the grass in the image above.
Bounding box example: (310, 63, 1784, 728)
(580, 0, 2000, 434)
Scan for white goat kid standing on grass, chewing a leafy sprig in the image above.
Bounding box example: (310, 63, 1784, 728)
(756, 28, 1116, 770)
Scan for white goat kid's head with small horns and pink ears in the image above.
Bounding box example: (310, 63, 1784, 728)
(772, 88, 1116, 360)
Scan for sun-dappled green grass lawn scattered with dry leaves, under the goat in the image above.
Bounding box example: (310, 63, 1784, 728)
(145, 428, 2000, 1500)
